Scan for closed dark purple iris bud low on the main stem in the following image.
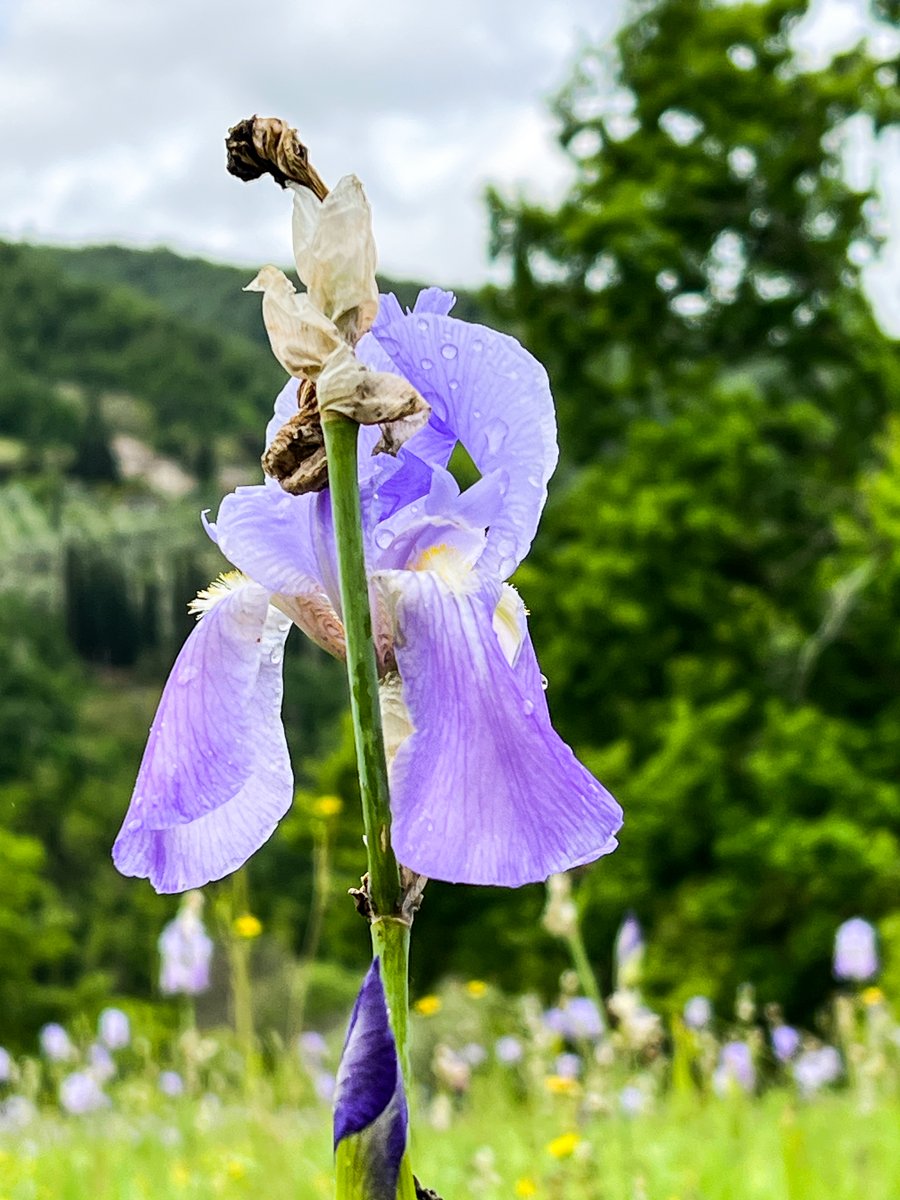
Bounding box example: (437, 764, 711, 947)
(335, 959, 409, 1200)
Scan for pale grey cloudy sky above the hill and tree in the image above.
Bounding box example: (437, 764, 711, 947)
(0, 0, 900, 326)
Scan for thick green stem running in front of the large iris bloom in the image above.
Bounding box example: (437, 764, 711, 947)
(322, 413, 409, 1079)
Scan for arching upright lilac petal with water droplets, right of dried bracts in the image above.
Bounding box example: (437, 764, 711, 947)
(374, 300, 558, 580)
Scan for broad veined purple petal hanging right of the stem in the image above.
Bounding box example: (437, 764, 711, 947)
(379, 570, 622, 887)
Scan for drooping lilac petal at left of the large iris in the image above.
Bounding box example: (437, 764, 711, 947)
(113, 581, 293, 892)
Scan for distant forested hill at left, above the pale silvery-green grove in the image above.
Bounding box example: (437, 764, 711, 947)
(0, 242, 489, 480)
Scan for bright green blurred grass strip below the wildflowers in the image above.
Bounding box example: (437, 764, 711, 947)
(0, 1094, 900, 1200)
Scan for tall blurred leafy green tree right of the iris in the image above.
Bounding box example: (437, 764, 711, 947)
(490, 0, 900, 1015)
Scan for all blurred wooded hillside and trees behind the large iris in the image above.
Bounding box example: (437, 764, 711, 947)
(0, 0, 900, 1044)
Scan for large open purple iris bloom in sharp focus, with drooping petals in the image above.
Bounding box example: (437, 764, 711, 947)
(114, 288, 622, 892)
